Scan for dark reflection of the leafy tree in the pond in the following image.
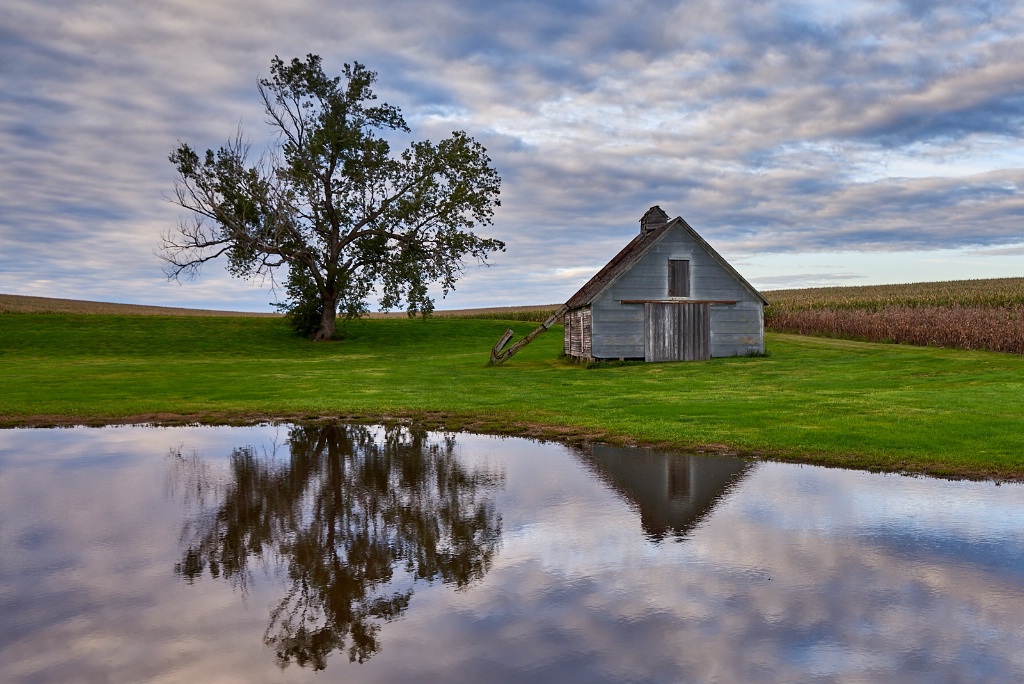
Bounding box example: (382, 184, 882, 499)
(174, 424, 504, 670)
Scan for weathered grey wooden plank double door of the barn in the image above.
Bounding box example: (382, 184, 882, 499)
(644, 302, 711, 361)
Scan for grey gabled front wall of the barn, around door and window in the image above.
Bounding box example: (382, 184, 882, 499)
(592, 226, 764, 358)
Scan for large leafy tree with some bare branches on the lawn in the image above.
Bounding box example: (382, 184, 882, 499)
(160, 54, 505, 340)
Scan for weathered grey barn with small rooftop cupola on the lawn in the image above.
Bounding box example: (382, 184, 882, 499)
(564, 207, 768, 361)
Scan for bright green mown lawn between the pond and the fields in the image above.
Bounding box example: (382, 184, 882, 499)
(0, 313, 1024, 479)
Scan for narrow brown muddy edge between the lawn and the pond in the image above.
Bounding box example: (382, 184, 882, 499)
(0, 411, 1024, 483)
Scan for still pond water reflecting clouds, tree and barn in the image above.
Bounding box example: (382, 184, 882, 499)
(0, 425, 1024, 684)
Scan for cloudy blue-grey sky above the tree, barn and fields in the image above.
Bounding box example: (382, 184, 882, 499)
(0, 0, 1024, 310)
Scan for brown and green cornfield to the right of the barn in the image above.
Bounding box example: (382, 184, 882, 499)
(764, 277, 1024, 354)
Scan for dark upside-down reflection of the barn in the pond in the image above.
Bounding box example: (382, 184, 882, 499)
(574, 444, 753, 542)
